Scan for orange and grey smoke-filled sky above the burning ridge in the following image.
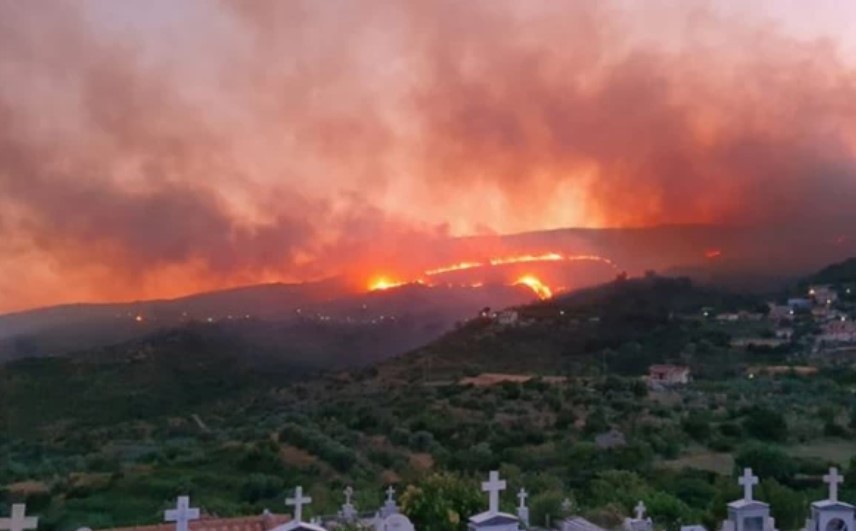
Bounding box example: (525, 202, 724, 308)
(0, 0, 856, 310)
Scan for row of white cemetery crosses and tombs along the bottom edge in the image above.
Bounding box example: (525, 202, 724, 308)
(0, 467, 856, 531)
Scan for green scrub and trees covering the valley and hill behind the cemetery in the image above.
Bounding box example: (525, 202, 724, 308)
(5, 278, 856, 531)
